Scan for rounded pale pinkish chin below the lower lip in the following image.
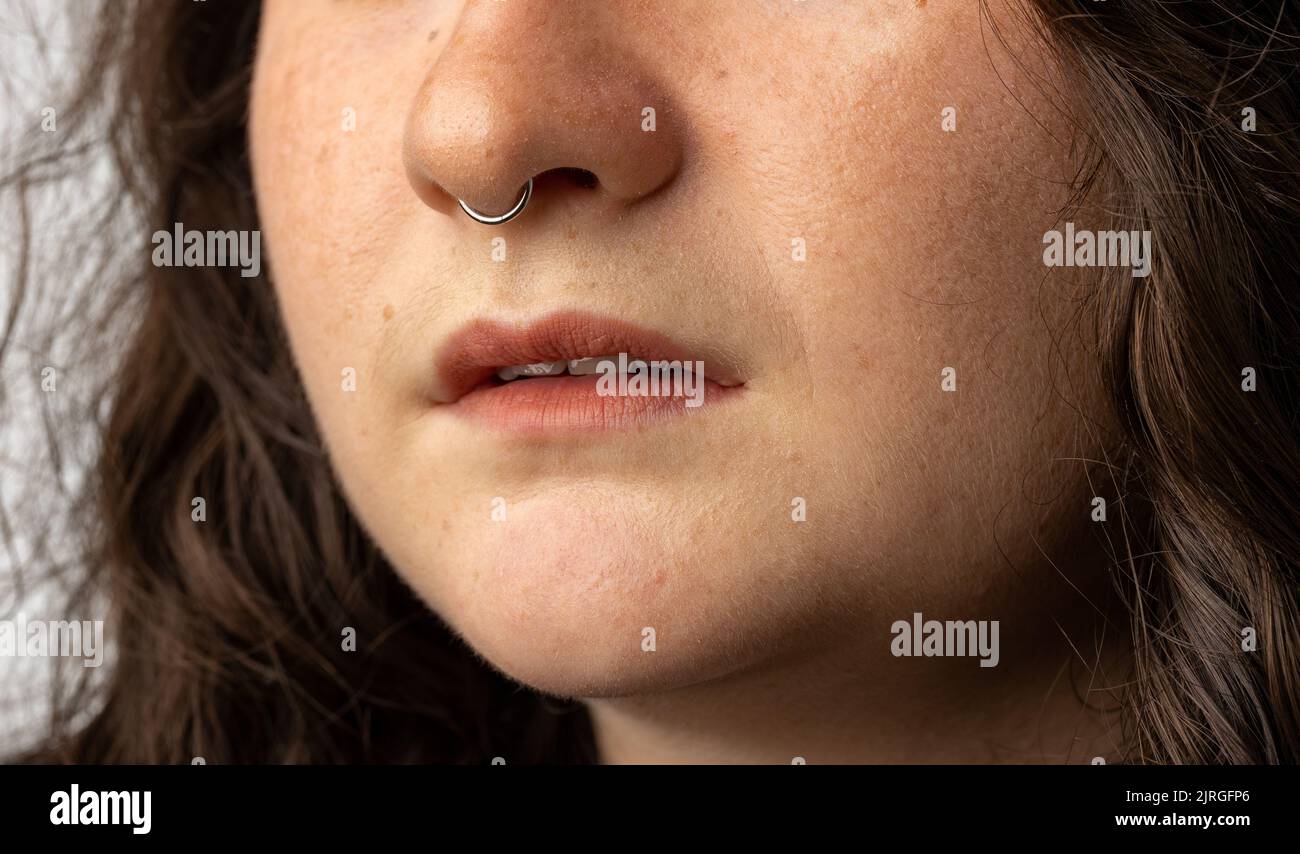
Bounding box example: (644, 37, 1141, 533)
(399, 499, 795, 698)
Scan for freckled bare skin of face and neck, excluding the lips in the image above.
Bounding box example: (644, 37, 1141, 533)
(251, 0, 1128, 763)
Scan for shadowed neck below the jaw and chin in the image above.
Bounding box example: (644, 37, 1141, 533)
(586, 608, 1123, 764)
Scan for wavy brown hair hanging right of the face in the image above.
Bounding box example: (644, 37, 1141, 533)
(1036, 0, 1300, 763)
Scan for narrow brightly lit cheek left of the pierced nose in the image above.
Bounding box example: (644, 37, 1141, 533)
(250, 12, 431, 436)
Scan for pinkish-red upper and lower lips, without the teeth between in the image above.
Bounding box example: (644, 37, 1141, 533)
(432, 311, 744, 434)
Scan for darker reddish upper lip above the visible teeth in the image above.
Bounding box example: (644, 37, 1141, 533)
(433, 312, 742, 403)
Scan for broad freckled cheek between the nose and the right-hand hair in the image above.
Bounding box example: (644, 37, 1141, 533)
(738, 4, 1104, 579)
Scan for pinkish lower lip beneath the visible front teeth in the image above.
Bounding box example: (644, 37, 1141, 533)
(450, 374, 740, 435)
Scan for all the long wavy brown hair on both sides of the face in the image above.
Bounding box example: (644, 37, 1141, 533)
(0, 0, 1300, 763)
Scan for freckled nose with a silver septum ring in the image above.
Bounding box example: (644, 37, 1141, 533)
(403, 0, 683, 222)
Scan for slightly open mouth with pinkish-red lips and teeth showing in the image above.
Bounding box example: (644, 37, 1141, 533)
(432, 312, 744, 434)
